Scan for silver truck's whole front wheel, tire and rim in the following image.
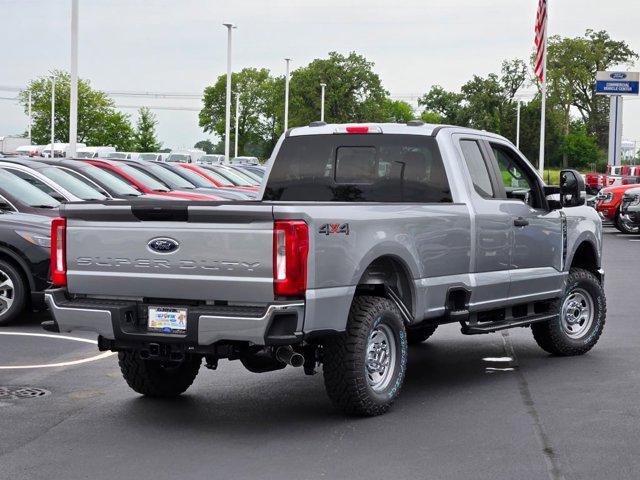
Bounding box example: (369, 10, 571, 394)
(531, 268, 607, 356)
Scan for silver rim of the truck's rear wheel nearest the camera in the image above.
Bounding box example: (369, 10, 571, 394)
(365, 324, 396, 392)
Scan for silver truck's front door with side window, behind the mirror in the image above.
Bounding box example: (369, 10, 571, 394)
(487, 139, 564, 302)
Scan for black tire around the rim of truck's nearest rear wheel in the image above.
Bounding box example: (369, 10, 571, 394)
(323, 296, 408, 416)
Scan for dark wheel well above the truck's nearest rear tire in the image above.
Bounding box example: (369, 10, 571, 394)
(356, 255, 415, 315)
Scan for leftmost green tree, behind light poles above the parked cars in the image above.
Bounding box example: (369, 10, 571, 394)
(19, 70, 134, 150)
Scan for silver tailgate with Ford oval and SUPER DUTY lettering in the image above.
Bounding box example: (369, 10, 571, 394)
(62, 202, 274, 302)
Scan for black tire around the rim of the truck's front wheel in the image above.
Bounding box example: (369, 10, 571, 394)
(531, 268, 607, 356)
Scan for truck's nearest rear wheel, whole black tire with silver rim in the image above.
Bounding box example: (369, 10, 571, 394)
(323, 296, 407, 416)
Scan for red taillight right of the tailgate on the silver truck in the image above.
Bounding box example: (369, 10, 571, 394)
(273, 220, 309, 296)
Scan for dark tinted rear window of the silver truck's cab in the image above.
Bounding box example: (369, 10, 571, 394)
(263, 134, 452, 203)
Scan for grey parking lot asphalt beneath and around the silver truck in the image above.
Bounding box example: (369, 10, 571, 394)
(0, 228, 640, 480)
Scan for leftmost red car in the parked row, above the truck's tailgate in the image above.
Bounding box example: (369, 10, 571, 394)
(85, 160, 223, 201)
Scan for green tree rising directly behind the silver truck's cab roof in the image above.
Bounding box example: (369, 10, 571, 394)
(289, 52, 388, 126)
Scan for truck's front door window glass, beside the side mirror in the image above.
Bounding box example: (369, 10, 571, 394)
(491, 143, 540, 208)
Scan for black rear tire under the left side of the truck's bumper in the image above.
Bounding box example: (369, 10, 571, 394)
(118, 351, 202, 398)
